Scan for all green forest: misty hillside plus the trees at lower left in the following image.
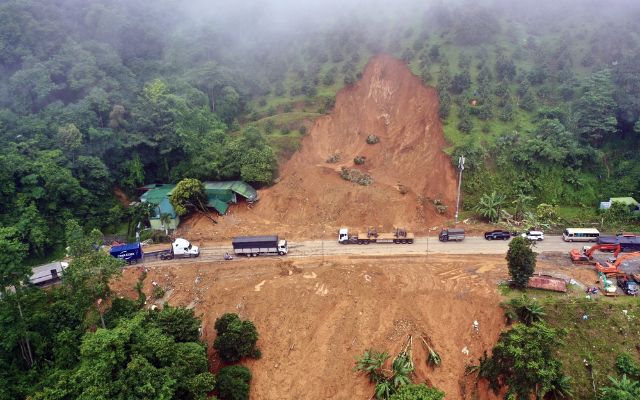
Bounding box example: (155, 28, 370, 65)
(0, 0, 640, 399)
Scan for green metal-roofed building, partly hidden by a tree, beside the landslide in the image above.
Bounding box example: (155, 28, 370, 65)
(140, 181, 258, 230)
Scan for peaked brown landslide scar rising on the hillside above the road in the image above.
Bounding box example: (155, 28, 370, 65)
(187, 55, 456, 240)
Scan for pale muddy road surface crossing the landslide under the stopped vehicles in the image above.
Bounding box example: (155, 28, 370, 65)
(186, 236, 589, 261)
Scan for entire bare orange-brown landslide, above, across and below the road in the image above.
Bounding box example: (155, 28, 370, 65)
(112, 55, 593, 400)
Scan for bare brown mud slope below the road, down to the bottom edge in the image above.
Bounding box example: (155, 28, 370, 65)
(112, 256, 506, 400)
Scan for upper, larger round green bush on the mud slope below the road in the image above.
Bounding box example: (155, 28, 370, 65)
(213, 314, 260, 362)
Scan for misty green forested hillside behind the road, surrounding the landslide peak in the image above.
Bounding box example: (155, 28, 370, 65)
(0, 0, 640, 259)
